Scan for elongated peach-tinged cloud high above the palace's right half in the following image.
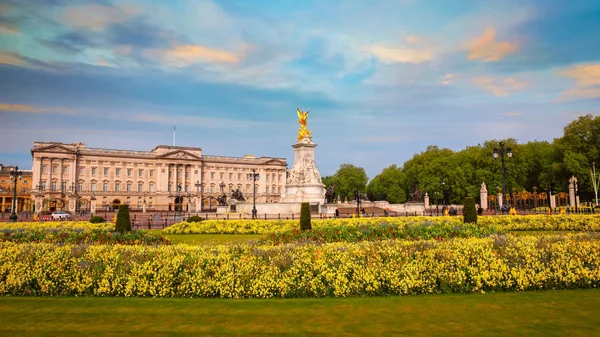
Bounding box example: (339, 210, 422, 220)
(144, 45, 242, 67)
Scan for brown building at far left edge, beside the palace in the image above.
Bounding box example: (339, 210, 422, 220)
(0, 164, 33, 212)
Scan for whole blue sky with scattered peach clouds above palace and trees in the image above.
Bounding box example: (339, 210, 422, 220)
(0, 0, 600, 178)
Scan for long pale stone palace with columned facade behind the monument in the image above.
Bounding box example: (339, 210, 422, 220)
(31, 142, 287, 213)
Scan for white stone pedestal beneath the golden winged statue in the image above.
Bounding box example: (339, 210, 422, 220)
(281, 137, 325, 204)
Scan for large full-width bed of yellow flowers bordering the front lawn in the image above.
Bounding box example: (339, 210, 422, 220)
(0, 234, 600, 298)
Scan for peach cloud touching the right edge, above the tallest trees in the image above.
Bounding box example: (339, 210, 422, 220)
(559, 63, 600, 101)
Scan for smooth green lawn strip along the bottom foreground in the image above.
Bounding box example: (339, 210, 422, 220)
(0, 289, 600, 336)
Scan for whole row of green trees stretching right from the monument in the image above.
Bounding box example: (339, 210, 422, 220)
(322, 114, 600, 204)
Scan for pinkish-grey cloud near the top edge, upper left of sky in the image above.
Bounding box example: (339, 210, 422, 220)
(61, 5, 140, 31)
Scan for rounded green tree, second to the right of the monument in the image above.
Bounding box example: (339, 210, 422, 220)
(367, 165, 406, 204)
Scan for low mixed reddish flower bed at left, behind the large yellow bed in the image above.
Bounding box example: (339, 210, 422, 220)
(0, 228, 170, 245)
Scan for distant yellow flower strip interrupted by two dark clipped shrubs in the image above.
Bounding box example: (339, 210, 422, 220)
(164, 215, 600, 234)
